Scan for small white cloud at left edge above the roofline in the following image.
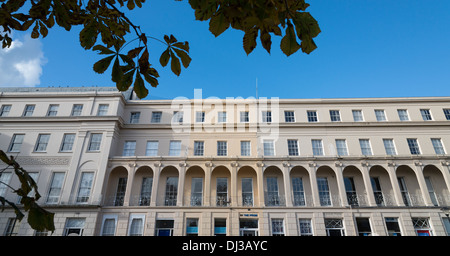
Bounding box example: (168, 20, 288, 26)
(0, 35, 46, 87)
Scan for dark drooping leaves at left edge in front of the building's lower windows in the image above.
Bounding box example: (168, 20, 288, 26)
(0, 150, 55, 232)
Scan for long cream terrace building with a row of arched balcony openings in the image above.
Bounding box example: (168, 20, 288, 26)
(0, 87, 450, 236)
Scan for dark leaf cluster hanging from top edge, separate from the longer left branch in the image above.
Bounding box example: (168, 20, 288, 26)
(189, 0, 320, 56)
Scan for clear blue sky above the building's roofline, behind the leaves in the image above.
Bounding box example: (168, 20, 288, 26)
(0, 0, 450, 99)
